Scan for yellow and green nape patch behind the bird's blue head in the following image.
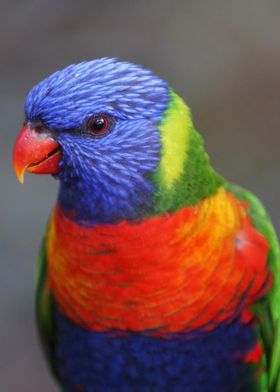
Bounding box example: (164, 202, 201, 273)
(152, 90, 224, 214)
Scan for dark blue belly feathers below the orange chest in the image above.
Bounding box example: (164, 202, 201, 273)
(56, 312, 259, 392)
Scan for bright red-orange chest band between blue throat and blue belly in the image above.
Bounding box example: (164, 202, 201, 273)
(47, 189, 271, 333)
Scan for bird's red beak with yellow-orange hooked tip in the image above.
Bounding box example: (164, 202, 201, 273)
(13, 123, 61, 183)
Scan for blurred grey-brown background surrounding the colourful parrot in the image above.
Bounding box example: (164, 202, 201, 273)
(0, 0, 280, 392)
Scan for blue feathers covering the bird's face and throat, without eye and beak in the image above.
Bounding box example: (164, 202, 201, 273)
(25, 58, 169, 223)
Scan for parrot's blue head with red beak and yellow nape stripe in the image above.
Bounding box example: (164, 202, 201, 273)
(14, 58, 222, 223)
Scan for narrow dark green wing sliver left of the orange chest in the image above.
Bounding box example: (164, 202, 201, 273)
(35, 225, 57, 377)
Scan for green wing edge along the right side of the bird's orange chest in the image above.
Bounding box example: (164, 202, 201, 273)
(226, 184, 280, 392)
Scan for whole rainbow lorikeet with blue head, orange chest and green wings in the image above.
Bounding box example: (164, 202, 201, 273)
(14, 58, 280, 392)
